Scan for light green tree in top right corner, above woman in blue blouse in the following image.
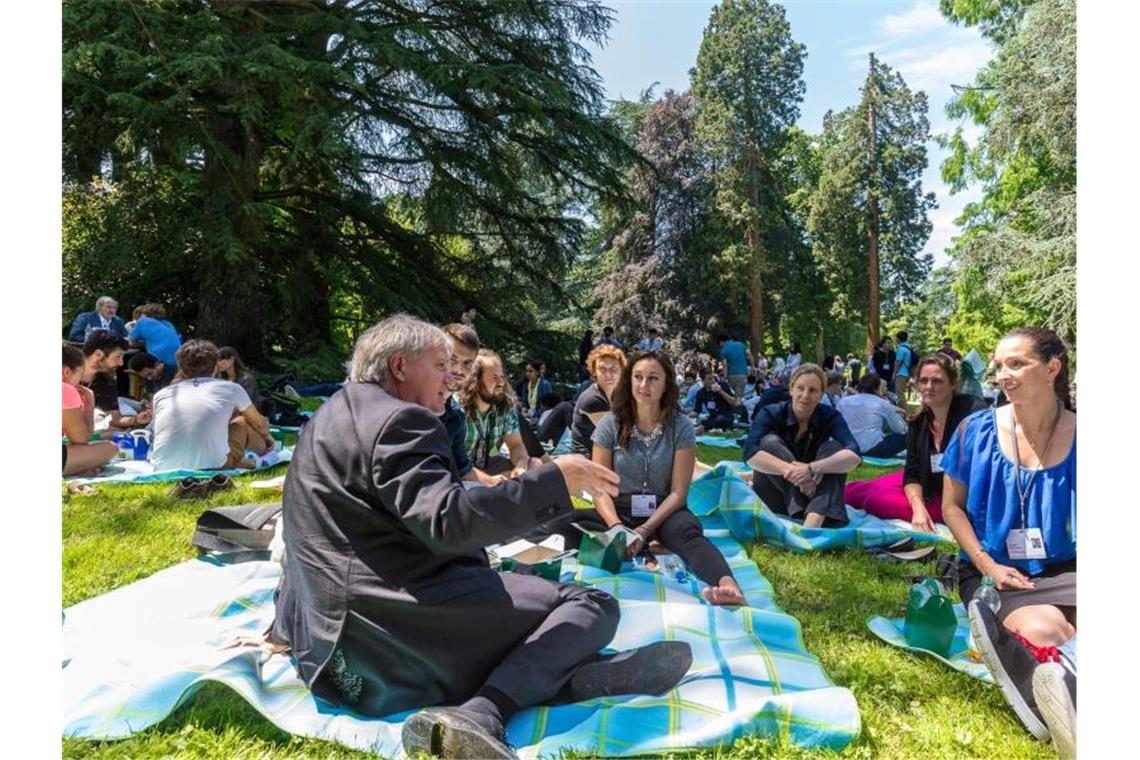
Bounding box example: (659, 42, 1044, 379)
(942, 0, 1076, 342)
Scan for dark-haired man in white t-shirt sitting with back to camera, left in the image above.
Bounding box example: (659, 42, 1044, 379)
(150, 341, 274, 469)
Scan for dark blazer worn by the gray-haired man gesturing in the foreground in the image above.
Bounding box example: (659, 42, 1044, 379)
(272, 383, 572, 701)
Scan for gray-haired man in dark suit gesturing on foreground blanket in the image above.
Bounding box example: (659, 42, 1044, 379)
(270, 314, 692, 758)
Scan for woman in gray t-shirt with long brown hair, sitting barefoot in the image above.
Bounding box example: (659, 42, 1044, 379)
(592, 351, 744, 604)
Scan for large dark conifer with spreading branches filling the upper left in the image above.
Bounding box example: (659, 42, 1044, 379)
(64, 0, 634, 358)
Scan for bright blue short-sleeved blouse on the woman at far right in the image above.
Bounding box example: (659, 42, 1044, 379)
(942, 409, 1076, 575)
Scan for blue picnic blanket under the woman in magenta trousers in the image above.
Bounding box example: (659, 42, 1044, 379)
(689, 461, 954, 551)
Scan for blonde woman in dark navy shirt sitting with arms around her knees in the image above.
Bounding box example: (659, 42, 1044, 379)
(743, 363, 862, 528)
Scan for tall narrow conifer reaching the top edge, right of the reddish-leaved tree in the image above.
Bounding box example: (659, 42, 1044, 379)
(691, 0, 807, 351)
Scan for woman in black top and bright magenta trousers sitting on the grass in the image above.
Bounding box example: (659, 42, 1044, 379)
(844, 353, 985, 533)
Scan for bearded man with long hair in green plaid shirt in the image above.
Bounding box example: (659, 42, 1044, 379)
(459, 349, 543, 484)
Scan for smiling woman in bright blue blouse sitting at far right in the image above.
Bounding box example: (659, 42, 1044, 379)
(942, 327, 1076, 738)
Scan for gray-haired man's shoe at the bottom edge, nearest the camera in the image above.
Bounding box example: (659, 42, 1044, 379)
(400, 708, 518, 760)
